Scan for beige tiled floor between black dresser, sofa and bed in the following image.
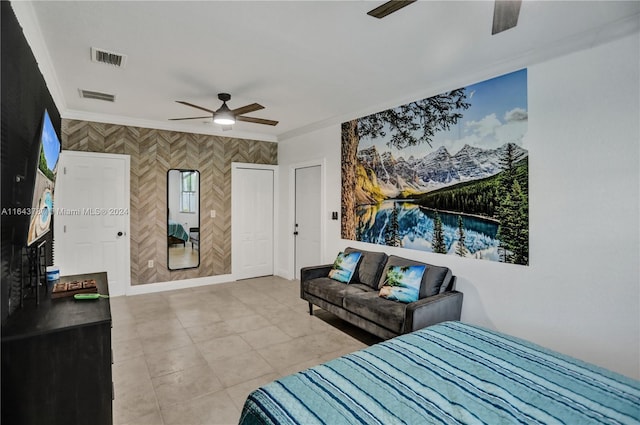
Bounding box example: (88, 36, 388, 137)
(110, 276, 379, 425)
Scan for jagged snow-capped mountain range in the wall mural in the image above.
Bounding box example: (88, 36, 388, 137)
(358, 144, 528, 197)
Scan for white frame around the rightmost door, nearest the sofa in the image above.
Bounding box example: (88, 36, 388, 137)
(287, 158, 327, 279)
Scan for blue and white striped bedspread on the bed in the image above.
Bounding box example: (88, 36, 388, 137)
(240, 322, 640, 425)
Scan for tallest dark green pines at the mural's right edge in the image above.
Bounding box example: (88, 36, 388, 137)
(496, 143, 529, 264)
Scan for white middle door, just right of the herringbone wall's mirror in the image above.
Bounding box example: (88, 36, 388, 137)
(231, 164, 275, 279)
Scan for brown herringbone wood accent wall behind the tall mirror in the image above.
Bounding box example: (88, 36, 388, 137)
(62, 120, 278, 285)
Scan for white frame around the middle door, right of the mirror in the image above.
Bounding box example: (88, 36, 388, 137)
(231, 162, 279, 280)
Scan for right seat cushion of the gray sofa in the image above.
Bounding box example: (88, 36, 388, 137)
(343, 291, 407, 334)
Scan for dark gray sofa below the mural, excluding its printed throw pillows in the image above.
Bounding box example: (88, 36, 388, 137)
(300, 248, 463, 339)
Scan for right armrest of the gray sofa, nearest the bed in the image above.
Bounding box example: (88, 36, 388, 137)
(403, 291, 463, 333)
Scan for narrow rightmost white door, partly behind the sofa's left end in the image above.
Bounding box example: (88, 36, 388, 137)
(294, 165, 322, 279)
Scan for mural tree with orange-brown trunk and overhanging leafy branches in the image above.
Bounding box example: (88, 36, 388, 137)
(341, 88, 471, 240)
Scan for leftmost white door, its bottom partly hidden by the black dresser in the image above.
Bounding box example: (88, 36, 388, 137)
(54, 151, 131, 295)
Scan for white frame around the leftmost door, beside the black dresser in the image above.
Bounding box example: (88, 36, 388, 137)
(54, 150, 131, 296)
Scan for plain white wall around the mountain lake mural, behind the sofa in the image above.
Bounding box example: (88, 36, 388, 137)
(278, 33, 640, 379)
